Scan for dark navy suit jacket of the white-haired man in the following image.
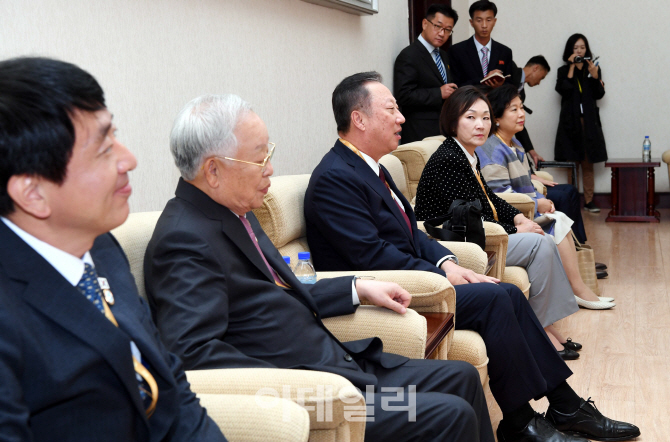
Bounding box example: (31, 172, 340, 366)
(145, 180, 408, 389)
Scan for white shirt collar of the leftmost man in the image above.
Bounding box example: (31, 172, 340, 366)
(0, 217, 95, 286)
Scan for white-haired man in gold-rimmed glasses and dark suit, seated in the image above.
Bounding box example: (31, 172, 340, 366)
(145, 95, 493, 441)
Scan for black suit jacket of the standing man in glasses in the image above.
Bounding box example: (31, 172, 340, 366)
(393, 40, 452, 144)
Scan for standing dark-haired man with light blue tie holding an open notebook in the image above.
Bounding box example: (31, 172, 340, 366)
(449, 0, 514, 87)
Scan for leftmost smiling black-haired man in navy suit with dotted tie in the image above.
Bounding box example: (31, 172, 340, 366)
(0, 58, 225, 442)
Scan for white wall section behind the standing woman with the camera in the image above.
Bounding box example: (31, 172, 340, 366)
(454, 0, 670, 192)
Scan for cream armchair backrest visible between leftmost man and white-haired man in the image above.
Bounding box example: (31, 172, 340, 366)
(112, 210, 162, 299)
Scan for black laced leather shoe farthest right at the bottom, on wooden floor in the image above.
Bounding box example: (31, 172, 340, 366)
(547, 398, 640, 441)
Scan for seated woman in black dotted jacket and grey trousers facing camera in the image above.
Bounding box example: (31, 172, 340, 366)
(415, 86, 581, 359)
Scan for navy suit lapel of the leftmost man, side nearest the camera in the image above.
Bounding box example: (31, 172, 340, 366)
(0, 221, 144, 422)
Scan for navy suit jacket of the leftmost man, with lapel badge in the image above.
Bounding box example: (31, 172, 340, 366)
(0, 221, 225, 442)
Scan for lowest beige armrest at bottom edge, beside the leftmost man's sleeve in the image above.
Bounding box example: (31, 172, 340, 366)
(198, 394, 309, 442)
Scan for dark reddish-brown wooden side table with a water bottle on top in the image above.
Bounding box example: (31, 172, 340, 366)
(605, 158, 661, 223)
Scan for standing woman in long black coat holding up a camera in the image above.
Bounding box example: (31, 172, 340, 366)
(554, 34, 607, 213)
